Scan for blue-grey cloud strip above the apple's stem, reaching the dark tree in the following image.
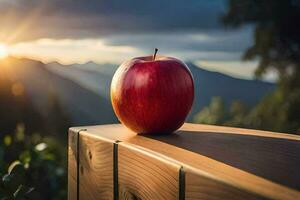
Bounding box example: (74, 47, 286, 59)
(105, 26, 253, 53)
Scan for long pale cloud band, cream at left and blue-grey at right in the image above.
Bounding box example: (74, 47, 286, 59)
(9, 27, 252, 64)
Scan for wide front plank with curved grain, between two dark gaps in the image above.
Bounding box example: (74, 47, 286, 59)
(118, 142, 180, 200)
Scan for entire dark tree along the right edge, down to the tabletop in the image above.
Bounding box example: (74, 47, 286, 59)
(223, 0, 300, 132)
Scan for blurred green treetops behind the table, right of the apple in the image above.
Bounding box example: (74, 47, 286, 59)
(193, 94, 300, 133)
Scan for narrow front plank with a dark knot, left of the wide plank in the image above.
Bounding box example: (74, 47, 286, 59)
(79, 131, 114, 200)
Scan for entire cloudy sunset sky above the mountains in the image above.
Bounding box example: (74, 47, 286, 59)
(0, 0, 274, 80)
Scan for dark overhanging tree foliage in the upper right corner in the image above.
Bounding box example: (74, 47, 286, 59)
(223, 0, 300, 75)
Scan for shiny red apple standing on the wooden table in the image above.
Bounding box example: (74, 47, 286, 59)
(111, 49, 194, 134)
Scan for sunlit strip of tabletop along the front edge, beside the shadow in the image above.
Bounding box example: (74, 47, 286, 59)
(127, 137, 300, 199)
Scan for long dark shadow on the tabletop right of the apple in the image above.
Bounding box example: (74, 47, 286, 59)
(143, 131, 300, 190)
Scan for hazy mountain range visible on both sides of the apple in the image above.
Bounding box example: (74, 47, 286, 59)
(0, 58, 274, 125)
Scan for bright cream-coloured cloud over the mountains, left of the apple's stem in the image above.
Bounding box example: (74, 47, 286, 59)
(8, 39, 138, 64)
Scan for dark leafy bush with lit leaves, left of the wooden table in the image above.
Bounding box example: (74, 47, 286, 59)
(0, 124, 67, 200)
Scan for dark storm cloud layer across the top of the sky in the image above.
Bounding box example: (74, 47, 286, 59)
(0, 0, 225, 42)
